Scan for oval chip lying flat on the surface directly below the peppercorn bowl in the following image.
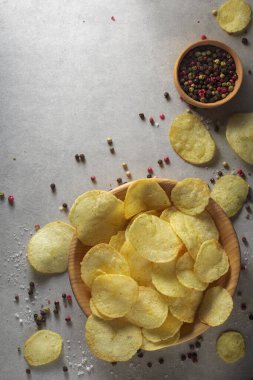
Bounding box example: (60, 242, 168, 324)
(169, 113, 215, 164)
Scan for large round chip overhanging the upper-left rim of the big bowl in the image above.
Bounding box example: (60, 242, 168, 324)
(69, 190, 126, 246)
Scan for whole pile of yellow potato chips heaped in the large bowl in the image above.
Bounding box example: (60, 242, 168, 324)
(66, 178, 239, 362)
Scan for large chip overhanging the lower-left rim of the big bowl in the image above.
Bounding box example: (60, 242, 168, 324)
(85, 315, 142, 362)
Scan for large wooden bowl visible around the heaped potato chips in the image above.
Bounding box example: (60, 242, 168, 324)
(68, 178, 240, 344)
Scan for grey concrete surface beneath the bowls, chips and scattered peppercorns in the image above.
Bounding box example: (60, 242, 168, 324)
(0, 0, 253, 380)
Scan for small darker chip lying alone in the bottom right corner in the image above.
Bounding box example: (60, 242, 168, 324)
(216, 331, 245, 363)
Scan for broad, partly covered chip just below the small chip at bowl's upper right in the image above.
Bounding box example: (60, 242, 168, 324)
(170, 211, 219, 260)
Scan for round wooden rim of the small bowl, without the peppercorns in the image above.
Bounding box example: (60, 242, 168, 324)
(173, 39, 243, 108)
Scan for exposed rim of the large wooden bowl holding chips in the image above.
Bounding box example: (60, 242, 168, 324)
(68, 177, 241, 346)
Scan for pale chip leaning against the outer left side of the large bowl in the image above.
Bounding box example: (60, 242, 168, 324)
(27, 221, 75, 274)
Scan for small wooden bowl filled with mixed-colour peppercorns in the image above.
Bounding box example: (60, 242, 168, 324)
(174, 39, 243, 108)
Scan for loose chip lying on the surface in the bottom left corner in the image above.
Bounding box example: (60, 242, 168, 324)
(24, 330, 63, 366)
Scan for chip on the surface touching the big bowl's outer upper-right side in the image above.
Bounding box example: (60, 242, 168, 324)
(211, 175, 249, 217)
